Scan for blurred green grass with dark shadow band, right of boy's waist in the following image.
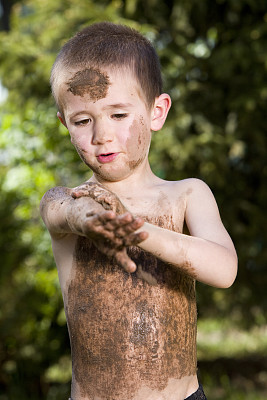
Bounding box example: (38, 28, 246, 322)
(198, 319, 267, 400)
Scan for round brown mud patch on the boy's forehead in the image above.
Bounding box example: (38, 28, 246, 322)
(67, 68, 110, 101)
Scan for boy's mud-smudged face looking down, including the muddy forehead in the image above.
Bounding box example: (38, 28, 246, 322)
(59, 68, 153, 181)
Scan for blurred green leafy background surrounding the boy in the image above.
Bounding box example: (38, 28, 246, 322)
(0, 0, 267, 400)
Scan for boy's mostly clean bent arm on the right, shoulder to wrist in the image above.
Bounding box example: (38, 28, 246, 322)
(138, 179, 237, 288)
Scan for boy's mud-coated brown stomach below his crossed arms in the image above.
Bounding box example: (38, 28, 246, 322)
(66, 237, 196, 400)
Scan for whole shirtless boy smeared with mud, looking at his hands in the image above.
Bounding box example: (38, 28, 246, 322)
(40, 23, 237, 400)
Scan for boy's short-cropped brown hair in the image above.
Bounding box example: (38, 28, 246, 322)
(50, 22, 162, 111)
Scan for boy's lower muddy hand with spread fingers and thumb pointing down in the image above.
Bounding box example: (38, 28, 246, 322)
(83, 211, 148, 272)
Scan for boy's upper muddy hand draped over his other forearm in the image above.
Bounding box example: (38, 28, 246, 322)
(71, 182, 127, 214)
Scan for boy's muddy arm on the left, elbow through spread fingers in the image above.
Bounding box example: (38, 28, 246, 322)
(40, 184, 148, 272)
